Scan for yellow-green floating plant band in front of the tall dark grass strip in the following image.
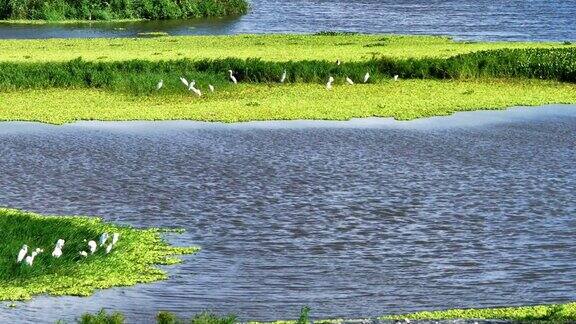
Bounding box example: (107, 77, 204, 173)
(0, 80, 576, 124)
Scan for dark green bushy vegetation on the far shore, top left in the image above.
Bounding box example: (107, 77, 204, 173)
(0, 0, 249, 22)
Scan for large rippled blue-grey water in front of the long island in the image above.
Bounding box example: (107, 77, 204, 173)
(0, 106, 576, 322)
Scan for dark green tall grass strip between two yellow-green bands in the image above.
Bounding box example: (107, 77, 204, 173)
(0, 48, 576, 94)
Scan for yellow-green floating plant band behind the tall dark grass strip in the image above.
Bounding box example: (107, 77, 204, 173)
(0, 35, 573, 62)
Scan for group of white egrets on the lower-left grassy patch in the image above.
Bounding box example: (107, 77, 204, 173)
(16, 233, 120, 266)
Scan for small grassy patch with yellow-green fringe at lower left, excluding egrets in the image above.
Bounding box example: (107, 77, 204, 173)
(0, 209, 198, 300)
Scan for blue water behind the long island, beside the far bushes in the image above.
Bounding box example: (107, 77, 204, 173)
(0, 0, 576, 41)
